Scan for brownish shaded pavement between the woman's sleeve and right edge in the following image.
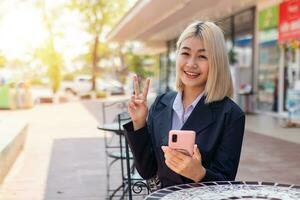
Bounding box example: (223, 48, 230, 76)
(236, 131, 300, 185)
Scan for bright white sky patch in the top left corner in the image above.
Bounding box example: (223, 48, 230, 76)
(0, 1, 44, 59)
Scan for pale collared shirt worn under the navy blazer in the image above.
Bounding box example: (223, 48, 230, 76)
(172, 92, 204, 130)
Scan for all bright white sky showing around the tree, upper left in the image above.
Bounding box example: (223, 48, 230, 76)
(0, 0, 90, 70)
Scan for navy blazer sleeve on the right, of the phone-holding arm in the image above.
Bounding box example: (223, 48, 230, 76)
(201, 108, 245, 182)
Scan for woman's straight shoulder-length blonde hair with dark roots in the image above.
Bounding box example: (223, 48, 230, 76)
(176, 21, 233, 103)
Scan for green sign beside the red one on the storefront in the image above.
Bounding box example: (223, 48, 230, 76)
(258, 5, 279, 30)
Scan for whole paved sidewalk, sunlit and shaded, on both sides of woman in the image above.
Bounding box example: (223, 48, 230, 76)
(0, 100, 300, 200)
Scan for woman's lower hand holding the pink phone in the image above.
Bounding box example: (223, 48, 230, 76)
(162, 145, 206, 182)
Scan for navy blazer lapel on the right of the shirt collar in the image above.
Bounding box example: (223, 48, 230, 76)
(181, 96, 214, 133)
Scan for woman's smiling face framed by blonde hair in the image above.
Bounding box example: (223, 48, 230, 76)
(176, 37, 209, 91)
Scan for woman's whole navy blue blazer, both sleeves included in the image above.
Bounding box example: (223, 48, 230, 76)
(124, 92, 245, 187)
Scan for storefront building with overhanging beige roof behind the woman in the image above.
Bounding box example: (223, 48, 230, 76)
(108, 0, 300, 119)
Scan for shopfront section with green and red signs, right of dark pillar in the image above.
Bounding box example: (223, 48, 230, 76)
(257, 0, 300, 121)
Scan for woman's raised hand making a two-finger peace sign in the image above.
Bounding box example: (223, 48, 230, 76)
(128, 75, 150, 130)
